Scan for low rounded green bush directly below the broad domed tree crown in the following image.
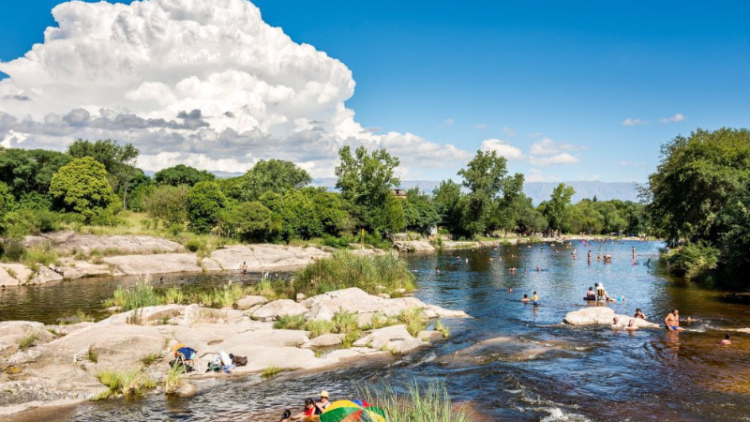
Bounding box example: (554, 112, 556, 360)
(225, 201, 282, 242)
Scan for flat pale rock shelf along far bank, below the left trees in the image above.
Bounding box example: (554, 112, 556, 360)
(0, 231, 382, 287)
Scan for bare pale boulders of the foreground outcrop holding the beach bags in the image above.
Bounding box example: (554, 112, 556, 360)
(0, 288, 467, 416)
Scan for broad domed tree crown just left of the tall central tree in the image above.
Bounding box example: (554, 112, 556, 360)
(235, 159, 312, 201)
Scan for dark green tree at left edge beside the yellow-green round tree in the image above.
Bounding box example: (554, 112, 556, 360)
(0, 148, 72, 198)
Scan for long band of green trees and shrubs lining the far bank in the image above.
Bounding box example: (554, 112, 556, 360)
(0, 139, 649, 284)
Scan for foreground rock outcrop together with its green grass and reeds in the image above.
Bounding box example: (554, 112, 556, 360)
(0, 252, 467, 420)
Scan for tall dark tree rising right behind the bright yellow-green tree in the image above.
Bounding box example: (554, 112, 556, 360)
(68, 139, 143, 209)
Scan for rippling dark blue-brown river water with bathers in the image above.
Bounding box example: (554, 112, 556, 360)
(2, 242, 750, 421)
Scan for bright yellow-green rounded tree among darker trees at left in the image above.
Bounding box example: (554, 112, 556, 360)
(49, 157, 117, 222)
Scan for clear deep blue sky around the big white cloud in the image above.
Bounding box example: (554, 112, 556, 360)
(0, 0, 750, 182)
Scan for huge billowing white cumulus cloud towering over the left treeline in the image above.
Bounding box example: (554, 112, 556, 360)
(0, 0, 471, 176)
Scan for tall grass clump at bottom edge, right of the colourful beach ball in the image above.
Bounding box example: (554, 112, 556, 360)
(359, 382, 472, 422)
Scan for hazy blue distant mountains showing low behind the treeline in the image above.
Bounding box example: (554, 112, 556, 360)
(312, 177, 638, 205)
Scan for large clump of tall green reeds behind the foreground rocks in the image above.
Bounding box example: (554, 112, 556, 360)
(294, 252, 415, 296)
